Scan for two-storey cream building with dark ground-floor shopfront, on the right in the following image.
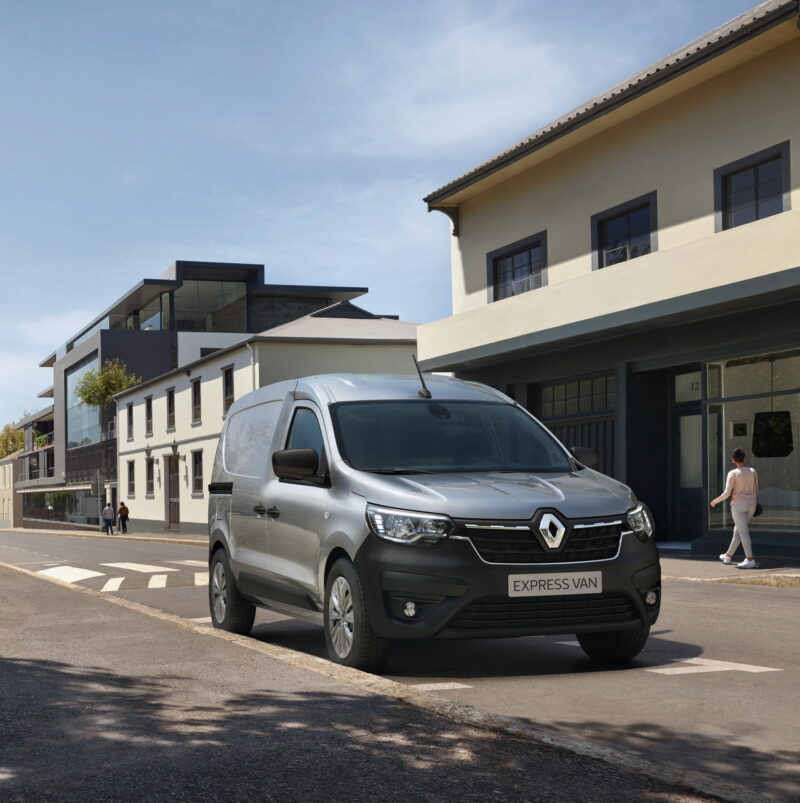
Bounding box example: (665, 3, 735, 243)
(418, 0, 800, 544)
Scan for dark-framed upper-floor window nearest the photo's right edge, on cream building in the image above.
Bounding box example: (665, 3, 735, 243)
(714, 140, 791, 231)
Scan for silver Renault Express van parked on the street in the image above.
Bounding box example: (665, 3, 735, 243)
(209, 374, 661, 671)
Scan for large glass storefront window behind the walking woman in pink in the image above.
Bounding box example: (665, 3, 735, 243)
(706, 350, 800, 532)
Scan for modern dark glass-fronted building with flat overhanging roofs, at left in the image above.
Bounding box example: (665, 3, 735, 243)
(16, 261, 367, 527)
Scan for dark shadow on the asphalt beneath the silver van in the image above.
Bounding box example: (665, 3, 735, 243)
(251, 620, 703, 679)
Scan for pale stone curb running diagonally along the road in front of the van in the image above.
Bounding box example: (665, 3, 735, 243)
(0, 560, 763, 803)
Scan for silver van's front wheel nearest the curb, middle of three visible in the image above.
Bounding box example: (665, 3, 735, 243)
(325, 558, 391, 672)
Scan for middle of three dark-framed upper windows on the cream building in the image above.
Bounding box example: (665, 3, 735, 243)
(591, 192, 658, 270)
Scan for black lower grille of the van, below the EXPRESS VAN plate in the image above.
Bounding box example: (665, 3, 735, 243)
(448, 594, 638, 631)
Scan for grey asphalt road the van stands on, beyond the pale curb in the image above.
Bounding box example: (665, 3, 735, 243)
(0, 533, 800, 800)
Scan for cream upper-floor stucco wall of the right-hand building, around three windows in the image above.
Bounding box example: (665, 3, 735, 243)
(418, 31, 800, 360)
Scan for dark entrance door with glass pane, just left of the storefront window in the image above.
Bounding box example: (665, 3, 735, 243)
(670, 406, 705, 540)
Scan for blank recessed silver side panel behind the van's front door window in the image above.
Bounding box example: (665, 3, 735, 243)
(222, 399, 283, 477)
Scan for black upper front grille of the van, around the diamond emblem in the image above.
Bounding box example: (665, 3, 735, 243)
(456, 522, 622, 563)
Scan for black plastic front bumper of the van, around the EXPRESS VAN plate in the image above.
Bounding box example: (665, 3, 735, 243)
(355, 533, 661, 639)
